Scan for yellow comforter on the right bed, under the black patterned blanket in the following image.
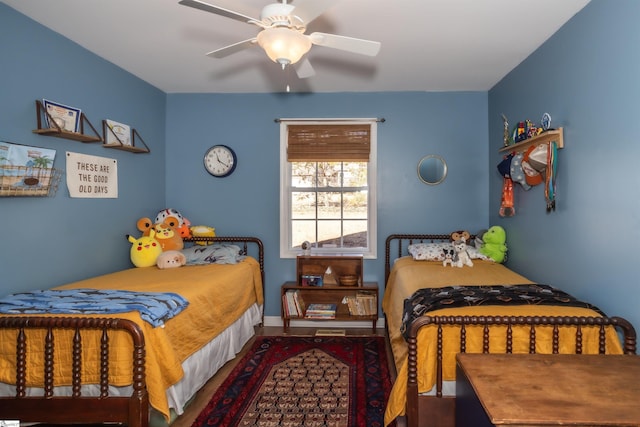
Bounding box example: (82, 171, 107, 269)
(382, 257, 622, 425)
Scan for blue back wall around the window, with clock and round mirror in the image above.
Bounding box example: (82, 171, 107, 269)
(166, 93, 488, 316)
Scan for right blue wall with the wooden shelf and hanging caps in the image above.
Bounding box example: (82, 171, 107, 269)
(489, 0, 640, 327)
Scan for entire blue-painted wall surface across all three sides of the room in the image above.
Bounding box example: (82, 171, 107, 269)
(0, 0, 640, 325)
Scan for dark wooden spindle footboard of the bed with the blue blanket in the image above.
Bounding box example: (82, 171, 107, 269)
(0, 316, 149, 427)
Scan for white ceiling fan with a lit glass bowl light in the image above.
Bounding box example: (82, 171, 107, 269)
(178, 0, 380, 78)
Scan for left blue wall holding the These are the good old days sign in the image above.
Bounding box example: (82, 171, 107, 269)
(0, 3, 166, 288)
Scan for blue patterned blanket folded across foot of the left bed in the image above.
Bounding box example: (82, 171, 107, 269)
(0, 289, 189, 327)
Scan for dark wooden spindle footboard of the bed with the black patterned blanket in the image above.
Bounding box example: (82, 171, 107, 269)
(406, 316, 637, 427)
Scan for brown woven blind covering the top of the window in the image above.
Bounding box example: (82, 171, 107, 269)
(287, 123, 371, 162)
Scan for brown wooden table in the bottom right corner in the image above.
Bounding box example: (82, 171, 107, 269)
(456, 354, 640, 427)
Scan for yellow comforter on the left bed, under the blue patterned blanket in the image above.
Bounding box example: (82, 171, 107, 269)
(0, 257, 263, 419)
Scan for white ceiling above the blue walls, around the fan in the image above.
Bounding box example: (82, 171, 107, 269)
(2, 0, 589, 93)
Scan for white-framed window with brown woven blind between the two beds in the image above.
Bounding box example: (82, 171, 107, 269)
(280, 119, 377, 258)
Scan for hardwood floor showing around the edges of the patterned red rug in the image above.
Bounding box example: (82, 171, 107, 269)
(171, 326, 404, 427)
